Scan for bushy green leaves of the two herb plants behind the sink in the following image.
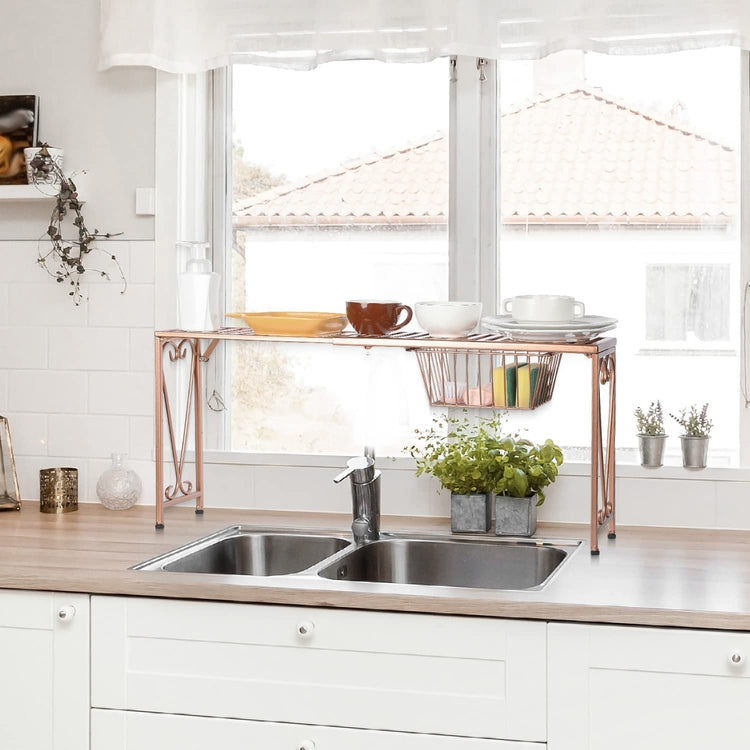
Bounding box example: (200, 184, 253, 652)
(406, 414, 563, 505)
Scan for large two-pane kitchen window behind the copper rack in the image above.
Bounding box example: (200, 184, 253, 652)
(214, 48, 747, 465)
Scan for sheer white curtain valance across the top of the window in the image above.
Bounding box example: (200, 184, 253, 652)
(99, 0, 750, 73)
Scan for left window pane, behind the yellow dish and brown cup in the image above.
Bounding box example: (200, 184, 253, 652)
(231, 60, 449, 453)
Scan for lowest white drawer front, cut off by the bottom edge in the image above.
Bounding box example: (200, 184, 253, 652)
(91, 709, 545, 750)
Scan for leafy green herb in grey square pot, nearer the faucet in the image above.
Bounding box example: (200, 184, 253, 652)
(406, 413, 503, 533)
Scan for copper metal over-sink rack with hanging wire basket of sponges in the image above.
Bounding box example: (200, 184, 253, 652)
(154, 328, 616, 554)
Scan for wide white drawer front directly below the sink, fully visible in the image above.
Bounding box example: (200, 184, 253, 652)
(92, 597, 546, 741)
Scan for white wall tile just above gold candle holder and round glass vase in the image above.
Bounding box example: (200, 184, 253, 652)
(49, 414, 129, 458)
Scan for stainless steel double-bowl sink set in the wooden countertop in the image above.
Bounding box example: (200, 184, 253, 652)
(134, 526, 580, 590)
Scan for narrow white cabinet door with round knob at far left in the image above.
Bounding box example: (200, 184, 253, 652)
(0, 591, 89, 750)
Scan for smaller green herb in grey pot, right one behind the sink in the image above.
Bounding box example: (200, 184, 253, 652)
(493, 436, 563, 536)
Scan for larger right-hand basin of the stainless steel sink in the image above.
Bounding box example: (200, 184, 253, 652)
(318, 539, 576, 589)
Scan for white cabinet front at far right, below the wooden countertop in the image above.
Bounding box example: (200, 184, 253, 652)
(548, 623, 750, 750)
